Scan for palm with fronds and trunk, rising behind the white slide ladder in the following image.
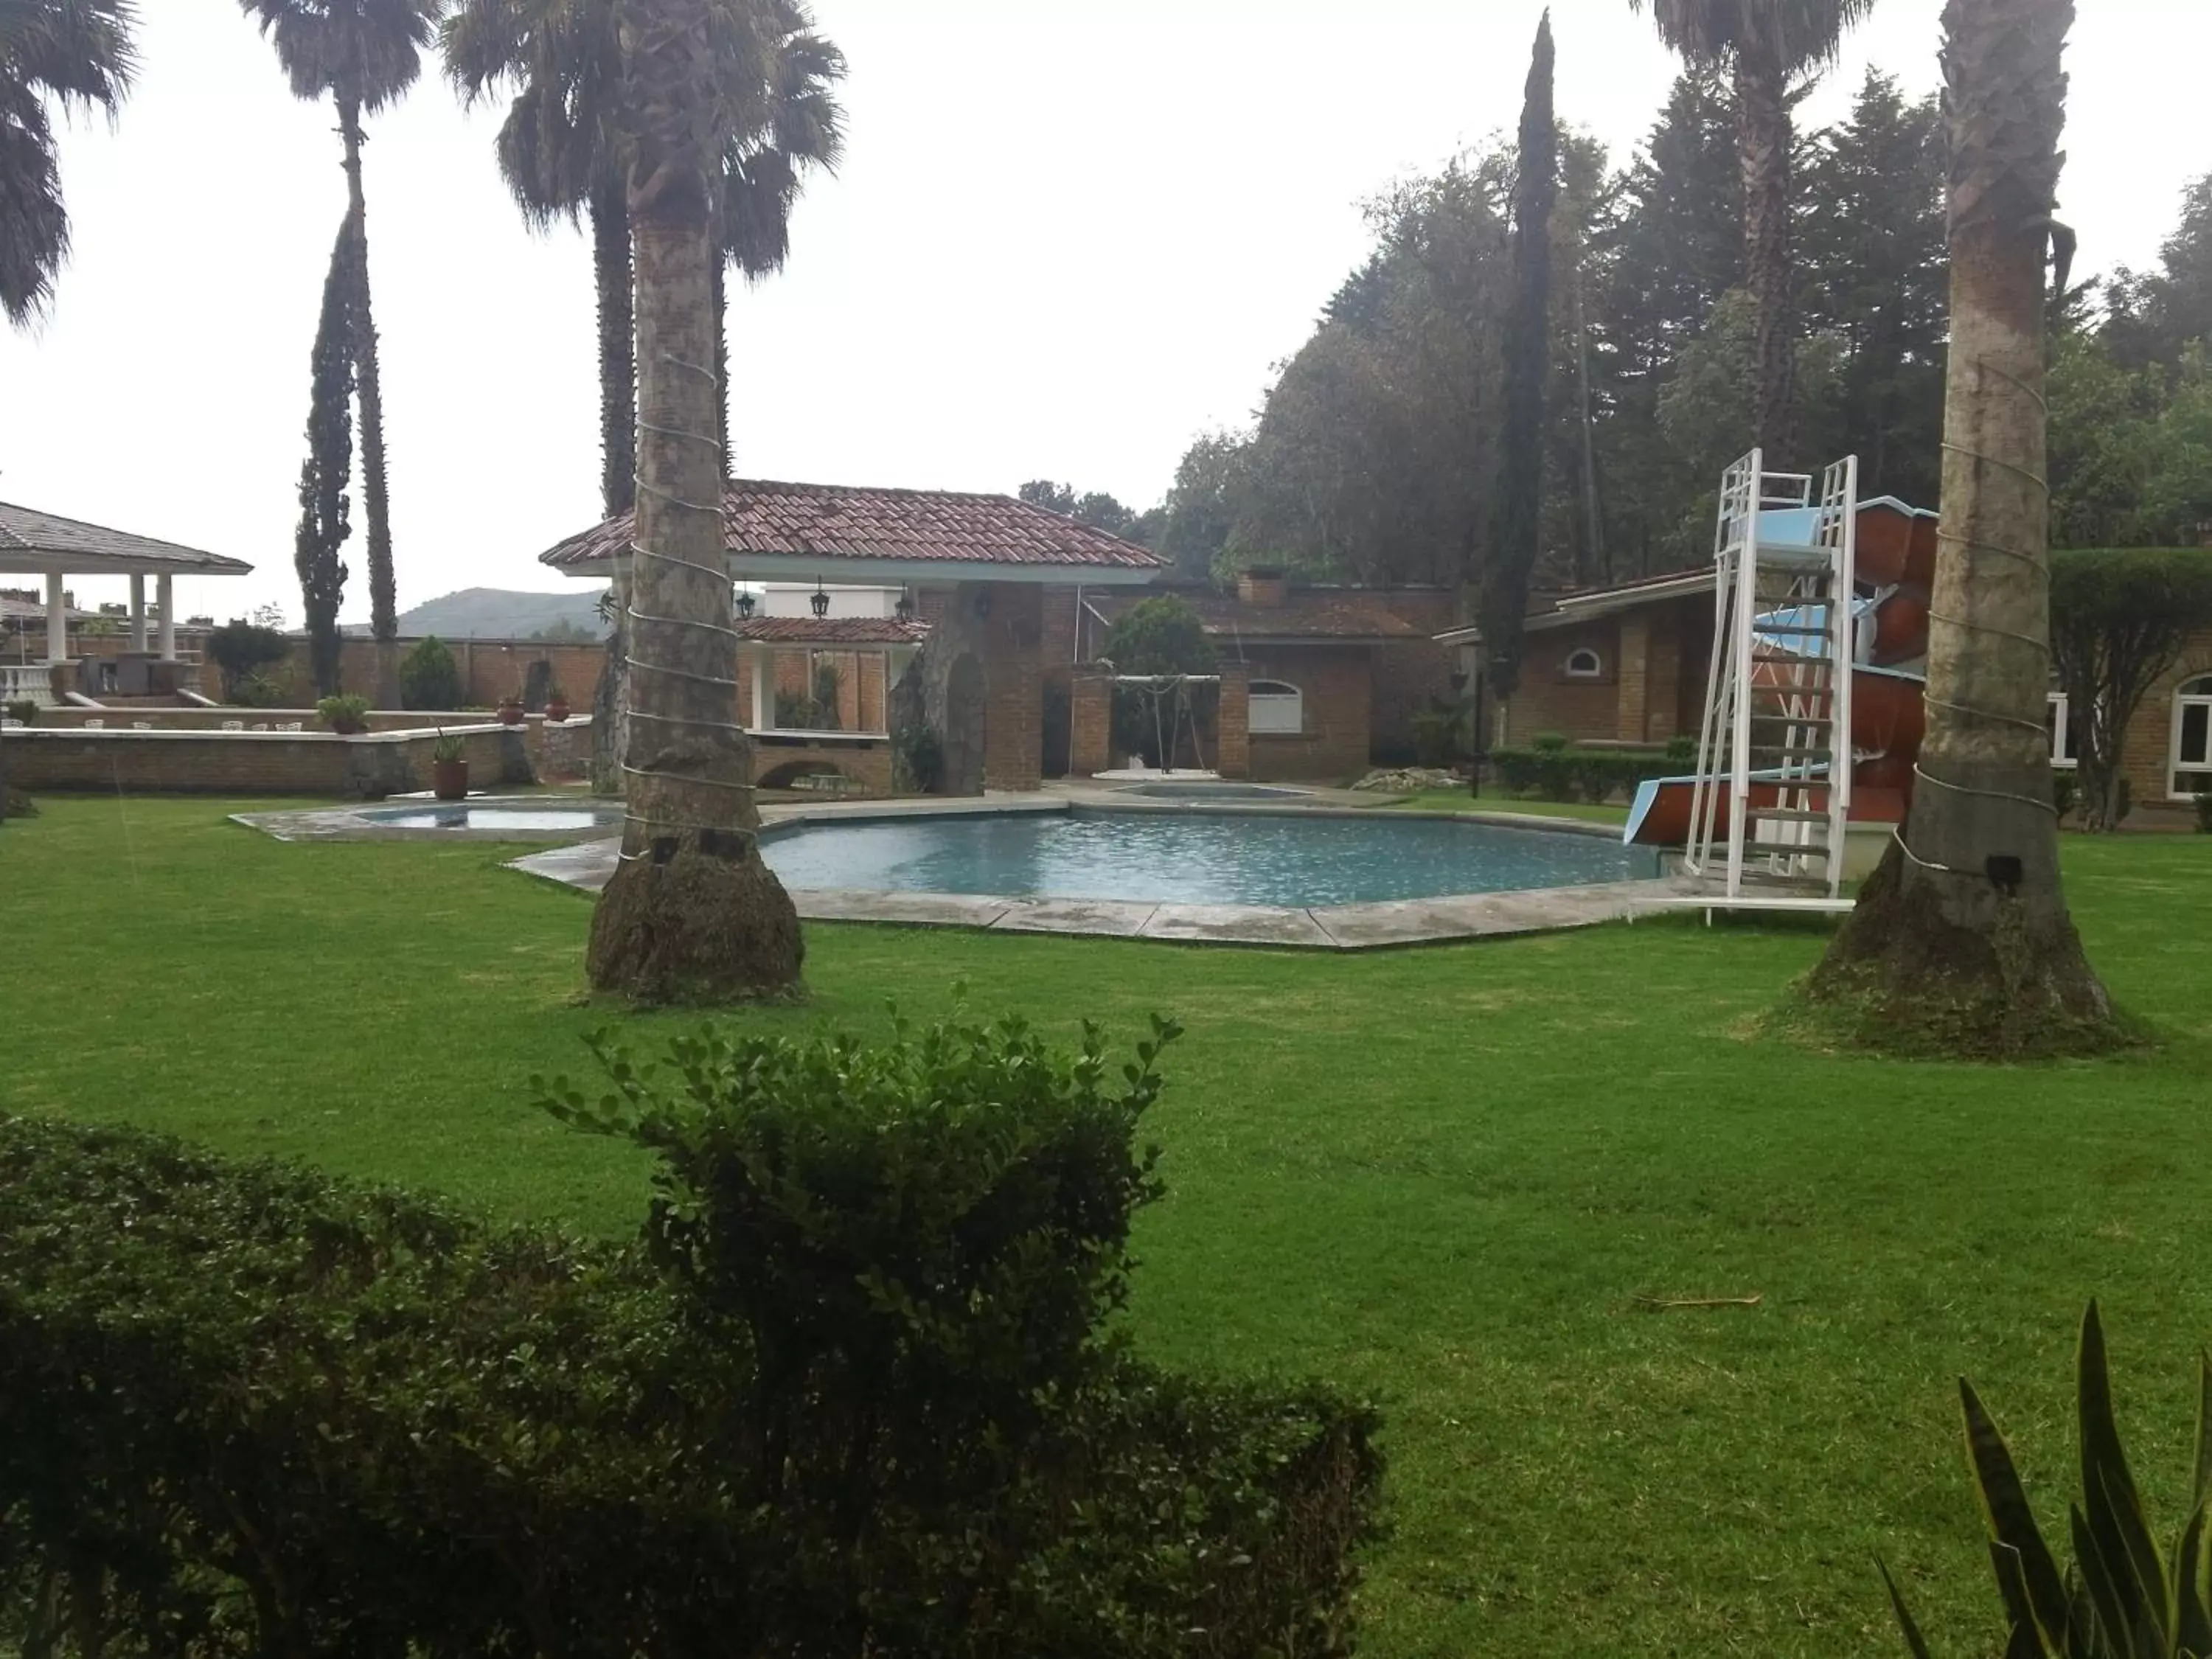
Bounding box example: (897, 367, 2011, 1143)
(1628, 0, 1874, 465)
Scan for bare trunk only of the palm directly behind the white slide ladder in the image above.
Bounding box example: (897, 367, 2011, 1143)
(1734, 40, 1796, 469)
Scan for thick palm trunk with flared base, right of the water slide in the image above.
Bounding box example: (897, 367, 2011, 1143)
(1812, 0, 2115, 1055)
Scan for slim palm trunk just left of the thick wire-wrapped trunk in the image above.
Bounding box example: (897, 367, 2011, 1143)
(584, 180, 637, 794)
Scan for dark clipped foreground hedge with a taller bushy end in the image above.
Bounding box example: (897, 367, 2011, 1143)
(0, 1022, 1380, 1659)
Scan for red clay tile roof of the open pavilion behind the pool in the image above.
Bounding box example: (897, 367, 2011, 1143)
(540, 478, 1164, 573)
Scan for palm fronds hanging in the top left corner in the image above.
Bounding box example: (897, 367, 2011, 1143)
(0, 0, 137, 327)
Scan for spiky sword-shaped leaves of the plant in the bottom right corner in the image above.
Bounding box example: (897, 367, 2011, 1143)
(1882, 1303, 2212, 1659)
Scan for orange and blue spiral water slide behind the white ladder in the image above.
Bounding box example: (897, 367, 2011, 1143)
(1621, 495, 1935, 847)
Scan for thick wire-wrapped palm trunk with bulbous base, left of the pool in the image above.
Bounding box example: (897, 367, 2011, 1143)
(586, 0, 803, 1002)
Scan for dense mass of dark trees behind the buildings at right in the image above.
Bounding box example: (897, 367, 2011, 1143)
(1152, 71, 2212, 606)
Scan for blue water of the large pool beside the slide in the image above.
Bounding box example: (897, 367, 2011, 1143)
(761, 812, 1659, 907)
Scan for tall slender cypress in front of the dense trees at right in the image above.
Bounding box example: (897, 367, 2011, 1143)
(1478, 11, 1559, 697)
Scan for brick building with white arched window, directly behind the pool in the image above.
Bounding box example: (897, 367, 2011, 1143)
(1075, 571, 1458, 779)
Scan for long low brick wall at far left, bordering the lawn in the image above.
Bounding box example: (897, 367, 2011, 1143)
(4, 726, 535, 799)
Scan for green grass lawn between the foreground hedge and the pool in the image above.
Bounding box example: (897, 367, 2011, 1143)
(0, 799, 2212, 1659)
